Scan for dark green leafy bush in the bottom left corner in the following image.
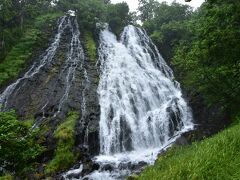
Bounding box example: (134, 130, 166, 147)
(0, 111, 44, 175)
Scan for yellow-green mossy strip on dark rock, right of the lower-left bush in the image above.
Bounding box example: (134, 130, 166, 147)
(45, 112, 79, 175)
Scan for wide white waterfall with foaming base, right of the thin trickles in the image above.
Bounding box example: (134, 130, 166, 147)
(83, 25, 193, 179)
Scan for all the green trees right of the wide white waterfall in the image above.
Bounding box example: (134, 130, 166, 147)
(139, 0, 240, 114)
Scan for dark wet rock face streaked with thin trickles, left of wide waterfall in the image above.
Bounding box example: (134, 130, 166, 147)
(0, 16, 100, 162)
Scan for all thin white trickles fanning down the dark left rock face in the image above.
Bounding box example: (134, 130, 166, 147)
(0, 13, 89, 129)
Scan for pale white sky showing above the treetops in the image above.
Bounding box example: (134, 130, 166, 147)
(111, 0, 205, 11)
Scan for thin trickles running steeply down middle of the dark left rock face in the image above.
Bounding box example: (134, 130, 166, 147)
(34, 15, 89, 127)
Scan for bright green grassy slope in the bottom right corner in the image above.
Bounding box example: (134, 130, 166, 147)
(137, 116, 240, 180)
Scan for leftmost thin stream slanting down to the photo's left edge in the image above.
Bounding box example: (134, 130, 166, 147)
(0, 16, 67, 111)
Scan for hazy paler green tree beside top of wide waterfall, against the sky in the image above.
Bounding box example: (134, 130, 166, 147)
(139, 0, 192, 61)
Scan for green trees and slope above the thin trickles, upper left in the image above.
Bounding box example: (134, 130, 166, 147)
(0, 0, 132, 86)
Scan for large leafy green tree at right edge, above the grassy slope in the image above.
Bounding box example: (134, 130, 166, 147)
(174, 1, 240, 111)
